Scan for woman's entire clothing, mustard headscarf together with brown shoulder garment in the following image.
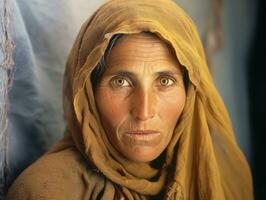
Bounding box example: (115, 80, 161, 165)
(7, 0, 253, 200)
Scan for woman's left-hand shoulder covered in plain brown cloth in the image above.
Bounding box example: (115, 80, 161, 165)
(7, 148, 108, 200)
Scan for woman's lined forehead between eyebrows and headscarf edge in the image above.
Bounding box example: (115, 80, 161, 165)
(106, 33, 180, 73)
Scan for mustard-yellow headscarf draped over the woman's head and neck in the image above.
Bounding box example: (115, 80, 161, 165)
(65, 0, 252, 200)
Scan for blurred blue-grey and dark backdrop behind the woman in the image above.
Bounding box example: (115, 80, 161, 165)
(0, 0, 266, 199)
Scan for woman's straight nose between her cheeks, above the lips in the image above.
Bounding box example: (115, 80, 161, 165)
(131, 89, 156, 121)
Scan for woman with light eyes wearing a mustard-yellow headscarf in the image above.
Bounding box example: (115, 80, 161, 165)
(7, 0, 253, 200)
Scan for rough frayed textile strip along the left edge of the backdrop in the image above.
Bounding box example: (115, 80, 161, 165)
(0, 0, 14, 199)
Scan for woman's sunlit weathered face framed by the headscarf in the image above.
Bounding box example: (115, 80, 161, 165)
(95, 34, 186, 162)
